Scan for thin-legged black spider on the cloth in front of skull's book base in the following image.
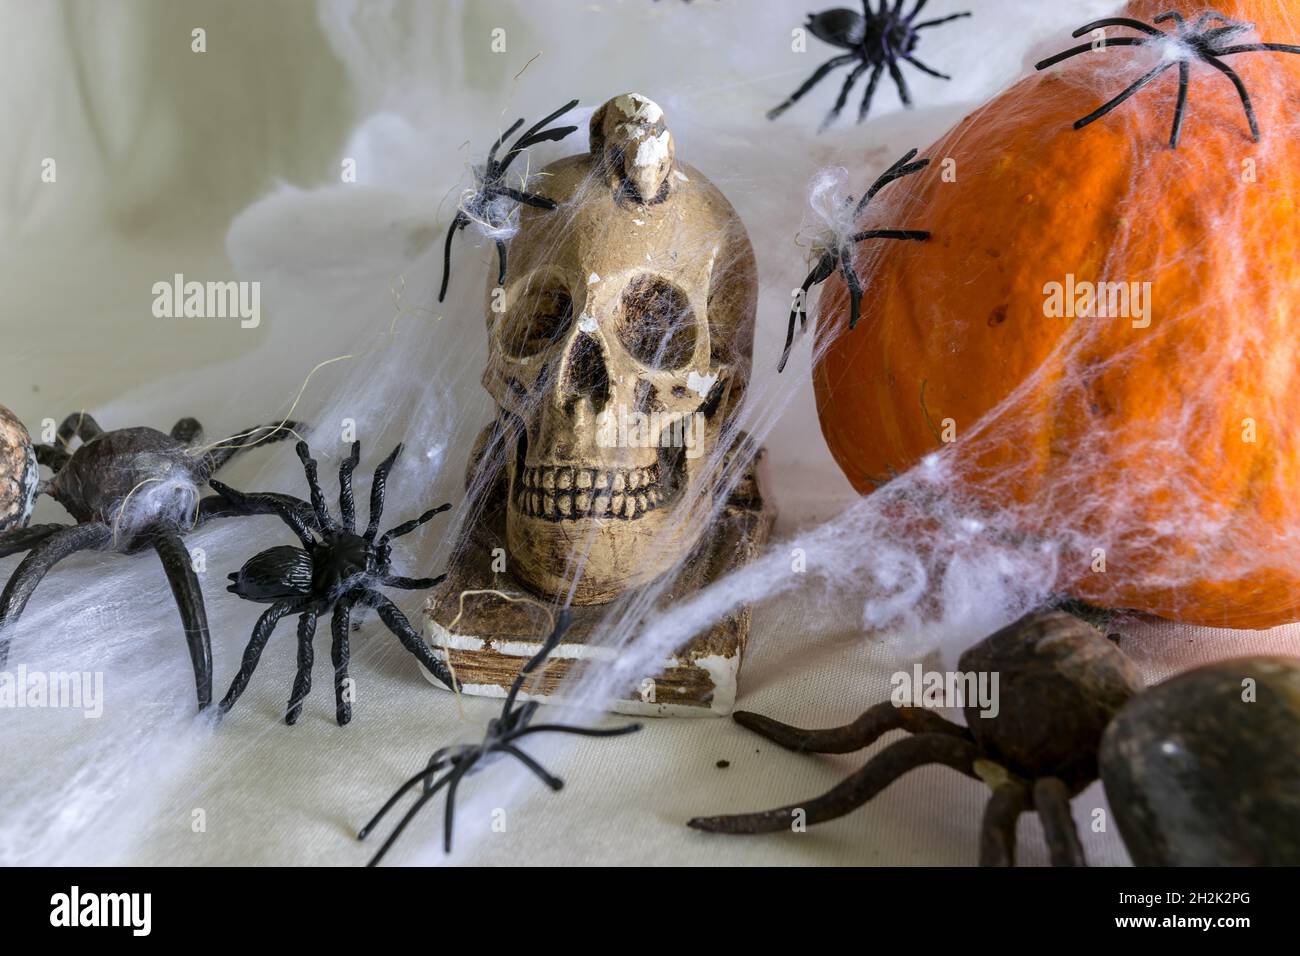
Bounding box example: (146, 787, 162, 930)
(356, 610, 641, 866)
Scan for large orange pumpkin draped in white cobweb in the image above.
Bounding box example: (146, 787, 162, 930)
(814, 0, 1300, 627)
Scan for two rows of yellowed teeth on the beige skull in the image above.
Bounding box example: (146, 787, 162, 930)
(515, 464, 667, 522)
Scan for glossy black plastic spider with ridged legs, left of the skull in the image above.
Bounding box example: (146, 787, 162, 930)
(212, 441, 454, 726)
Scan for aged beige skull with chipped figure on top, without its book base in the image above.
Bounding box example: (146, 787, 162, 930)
(484, 94, 757, 604)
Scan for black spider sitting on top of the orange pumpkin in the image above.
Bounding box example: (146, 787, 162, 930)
(1035, 10, 1300, 150)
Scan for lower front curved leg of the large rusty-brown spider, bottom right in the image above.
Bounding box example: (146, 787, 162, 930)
(686, 734, 980, 834)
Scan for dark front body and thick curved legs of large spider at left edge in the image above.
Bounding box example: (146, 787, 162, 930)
(0, 412, 298, 710)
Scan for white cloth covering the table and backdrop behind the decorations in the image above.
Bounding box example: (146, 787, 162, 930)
(0, 0, 1297, 865)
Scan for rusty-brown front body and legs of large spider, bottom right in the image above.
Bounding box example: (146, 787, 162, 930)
(689, 611, 1143, 866)
